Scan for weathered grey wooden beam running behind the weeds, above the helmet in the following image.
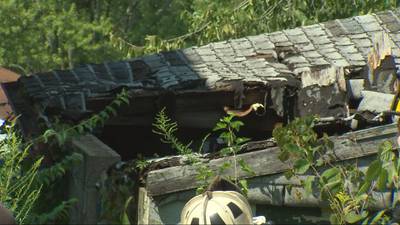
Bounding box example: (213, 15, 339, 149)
(147, 124, 397, 196)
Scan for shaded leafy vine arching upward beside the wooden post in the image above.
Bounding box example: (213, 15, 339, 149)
(18, 89, 130, 224)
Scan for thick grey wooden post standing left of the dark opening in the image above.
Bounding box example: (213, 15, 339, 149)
(69, 135, 120, 224)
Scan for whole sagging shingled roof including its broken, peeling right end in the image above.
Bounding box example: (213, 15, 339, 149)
(4, 9, 400, 140)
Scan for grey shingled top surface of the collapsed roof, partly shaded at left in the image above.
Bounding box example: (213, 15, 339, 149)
(16, 9, 400, 114)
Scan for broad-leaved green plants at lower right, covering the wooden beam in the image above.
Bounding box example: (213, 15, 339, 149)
(273, 117, 400, 224)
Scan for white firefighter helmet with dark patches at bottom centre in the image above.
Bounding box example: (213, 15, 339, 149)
(180, 178, 253, 225)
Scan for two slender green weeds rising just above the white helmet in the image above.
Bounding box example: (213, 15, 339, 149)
(153, 108, 254, 193)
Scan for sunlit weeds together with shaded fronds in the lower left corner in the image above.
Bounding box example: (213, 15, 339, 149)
(0, 119, 82, 224)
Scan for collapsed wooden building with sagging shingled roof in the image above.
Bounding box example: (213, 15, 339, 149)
(2, 7, 400, 224)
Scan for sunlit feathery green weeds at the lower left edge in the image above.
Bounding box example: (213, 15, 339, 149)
(0, 121, 42, 224)
